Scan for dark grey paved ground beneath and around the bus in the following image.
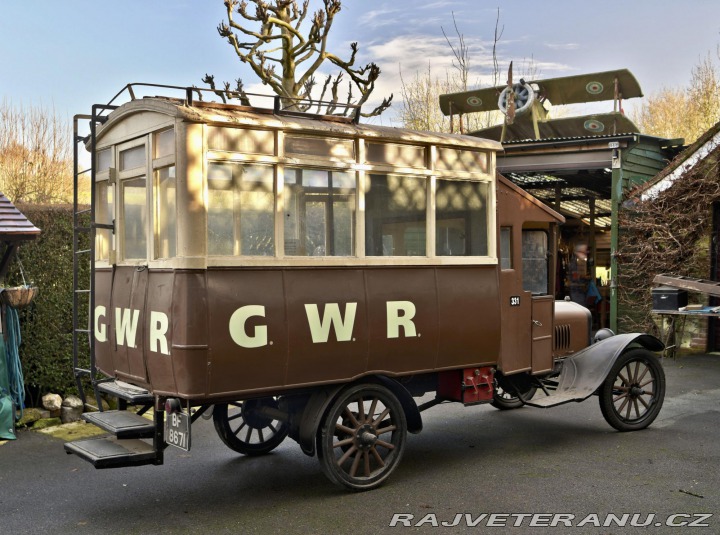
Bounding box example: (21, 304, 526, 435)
(0, 355, 720, 535)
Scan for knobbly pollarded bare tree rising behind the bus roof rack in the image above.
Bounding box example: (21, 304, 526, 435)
(211, 0, 392, 117)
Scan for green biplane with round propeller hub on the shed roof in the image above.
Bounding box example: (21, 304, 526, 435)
(440, 63, 643, 141)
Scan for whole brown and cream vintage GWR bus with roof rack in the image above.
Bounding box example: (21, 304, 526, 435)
(66, 86, 665, 490)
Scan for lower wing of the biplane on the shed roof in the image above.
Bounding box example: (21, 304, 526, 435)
(472, 112, 640, 141)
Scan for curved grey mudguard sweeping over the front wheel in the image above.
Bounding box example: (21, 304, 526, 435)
(525, 333, 665, 408)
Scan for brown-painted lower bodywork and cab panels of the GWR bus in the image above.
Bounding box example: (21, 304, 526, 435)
(95, 179, 590, 400)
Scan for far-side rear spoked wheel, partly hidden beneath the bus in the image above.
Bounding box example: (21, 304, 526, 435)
(213, 398, 289, 455)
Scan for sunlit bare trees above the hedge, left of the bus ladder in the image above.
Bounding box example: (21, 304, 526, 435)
(0, 100, 73, 203)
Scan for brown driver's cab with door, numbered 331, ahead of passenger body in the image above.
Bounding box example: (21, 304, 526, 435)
(497, 176, 565, 375)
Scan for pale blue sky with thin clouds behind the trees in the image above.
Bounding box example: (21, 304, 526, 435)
(0, 0, 720, 125)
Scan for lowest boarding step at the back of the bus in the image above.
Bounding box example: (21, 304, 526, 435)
(65, 437, 163, 468)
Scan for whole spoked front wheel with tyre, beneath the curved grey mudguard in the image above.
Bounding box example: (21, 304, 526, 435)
(600, 349, 665, 431)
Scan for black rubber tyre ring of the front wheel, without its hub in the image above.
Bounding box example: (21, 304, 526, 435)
(600, 349, 665, 431)
